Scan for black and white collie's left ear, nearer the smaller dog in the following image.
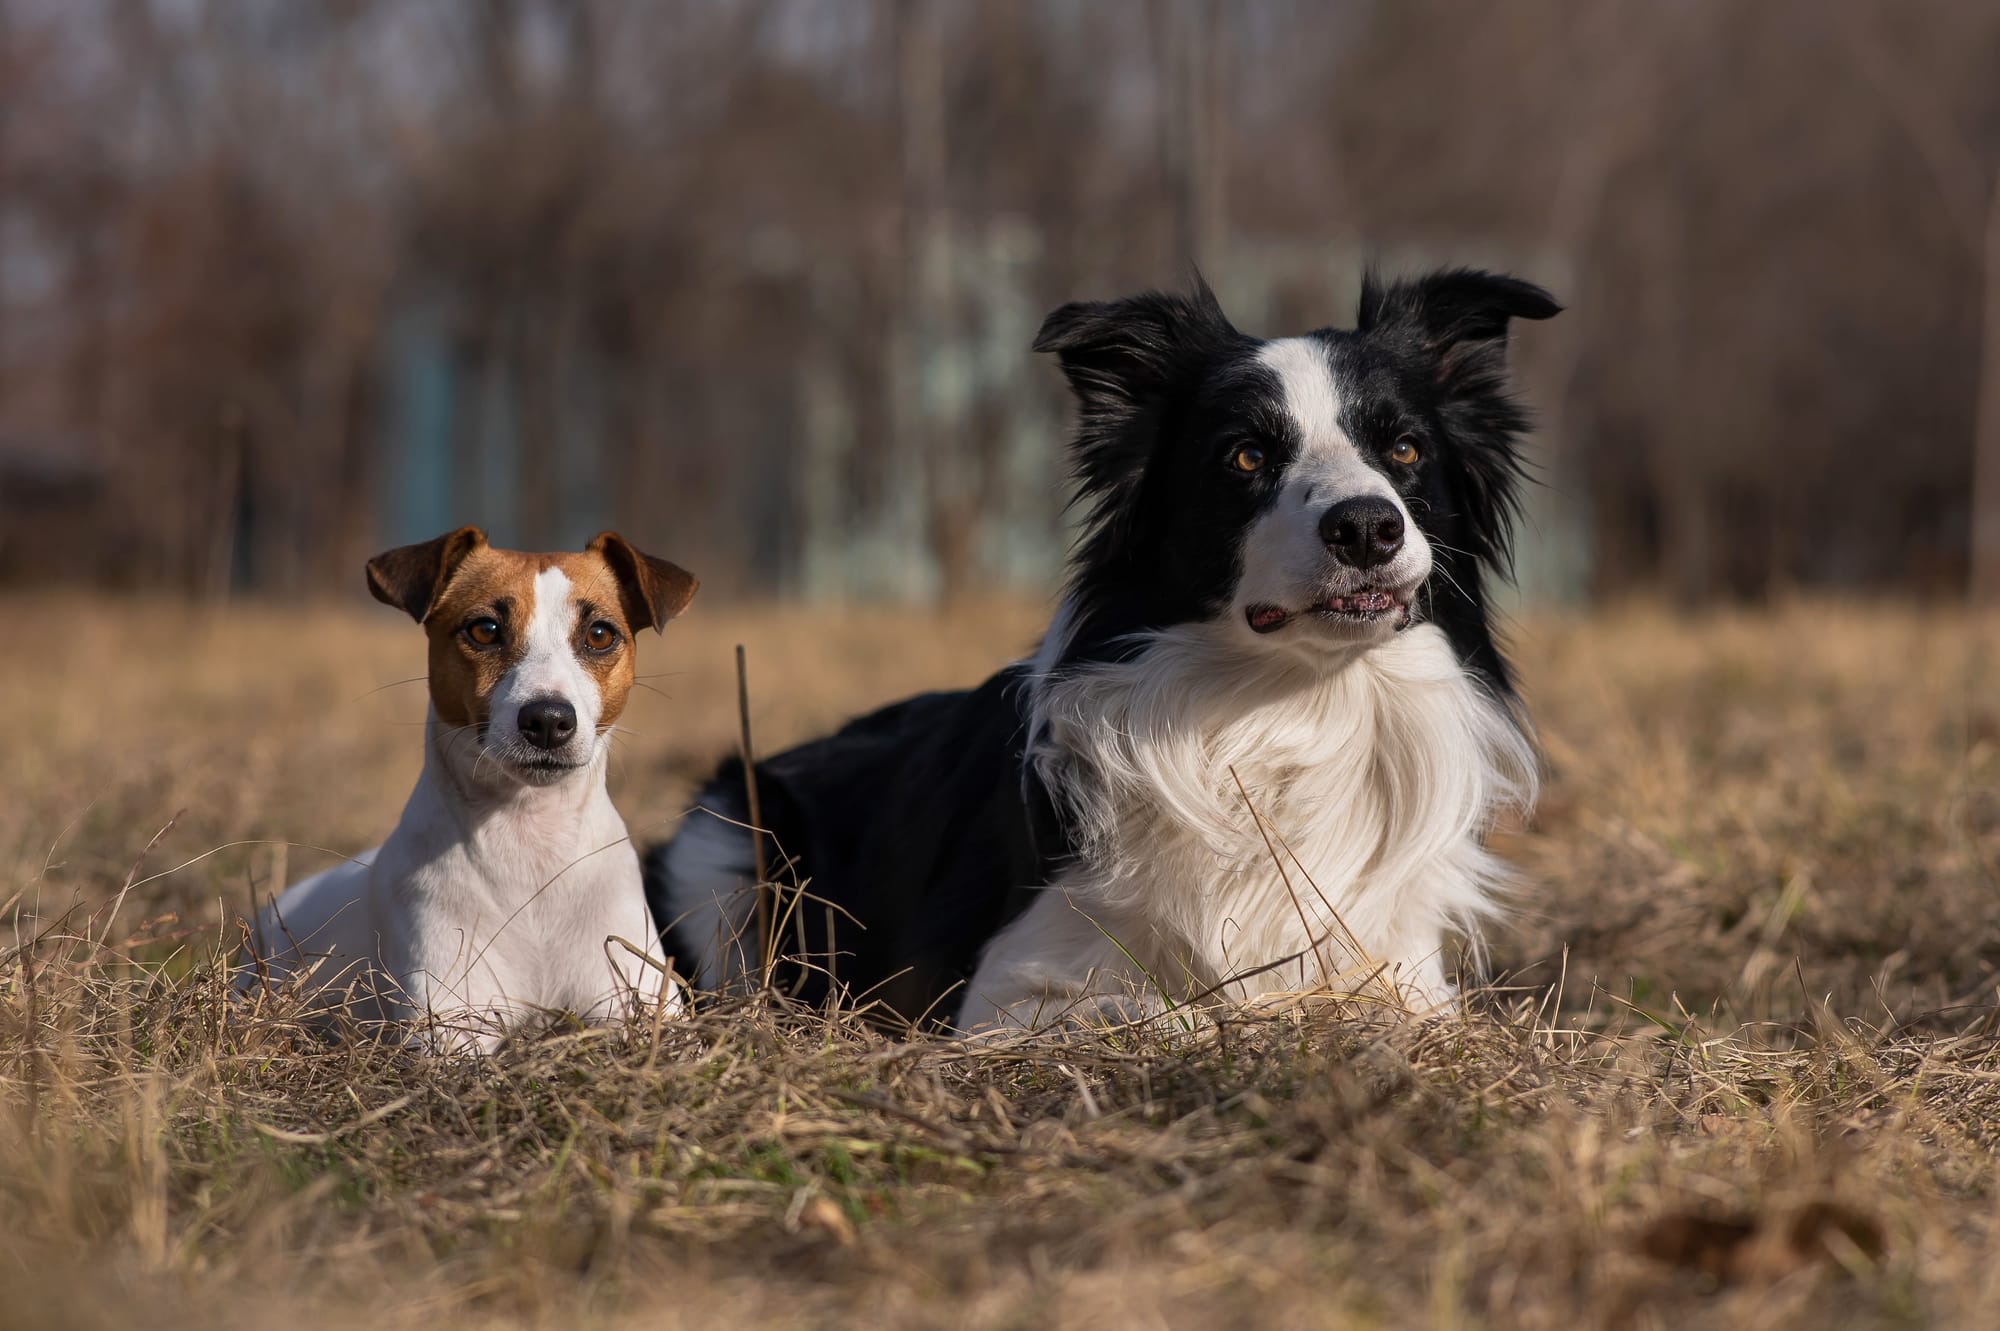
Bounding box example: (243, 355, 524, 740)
(1034, 278, 1242, 492)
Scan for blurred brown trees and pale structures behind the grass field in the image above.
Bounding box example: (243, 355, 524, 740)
(0, 0, 2000, 602)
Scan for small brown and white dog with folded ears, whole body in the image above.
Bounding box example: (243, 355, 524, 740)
(238, 528, 696, 1051)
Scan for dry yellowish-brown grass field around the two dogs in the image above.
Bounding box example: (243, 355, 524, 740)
(0, 598, 2000, 1329)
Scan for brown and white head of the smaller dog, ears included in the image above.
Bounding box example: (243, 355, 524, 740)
(368, 528, 694, 785)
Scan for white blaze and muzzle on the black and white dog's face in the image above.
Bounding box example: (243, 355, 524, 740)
(1232, 338, 1430, 644)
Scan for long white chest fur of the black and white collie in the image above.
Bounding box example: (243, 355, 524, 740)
(960, 626, 1534, 1027)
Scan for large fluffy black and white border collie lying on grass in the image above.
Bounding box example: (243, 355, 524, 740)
(646, 270, 1560, 1029)
